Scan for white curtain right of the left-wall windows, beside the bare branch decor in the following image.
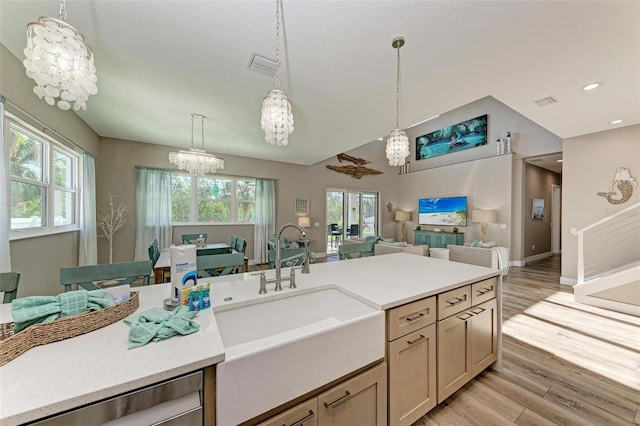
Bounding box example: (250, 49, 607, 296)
(78, 151, 98, 266)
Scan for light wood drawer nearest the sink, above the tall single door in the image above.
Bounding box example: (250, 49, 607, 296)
(387, 296, 436, 341)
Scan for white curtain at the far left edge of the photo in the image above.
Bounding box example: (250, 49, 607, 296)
(0, 97, 11, 272)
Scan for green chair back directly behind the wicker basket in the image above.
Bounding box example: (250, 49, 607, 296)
(60, 260, 152, 291)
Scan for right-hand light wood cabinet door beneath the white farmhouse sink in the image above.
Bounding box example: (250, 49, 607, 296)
(318, 363, 387, 426)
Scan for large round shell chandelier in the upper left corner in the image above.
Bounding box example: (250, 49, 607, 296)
(22, 0, 98, 111)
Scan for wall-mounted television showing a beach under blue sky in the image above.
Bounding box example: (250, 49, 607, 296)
(418, 196, 467, 226)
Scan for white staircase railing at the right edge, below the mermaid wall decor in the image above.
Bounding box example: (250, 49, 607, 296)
(572, 203, 640, 284)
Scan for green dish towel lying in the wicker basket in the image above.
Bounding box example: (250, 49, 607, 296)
(11, 290, 115, 333)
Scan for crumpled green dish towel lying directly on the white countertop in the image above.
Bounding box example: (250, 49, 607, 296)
(124, 306, 200, 349)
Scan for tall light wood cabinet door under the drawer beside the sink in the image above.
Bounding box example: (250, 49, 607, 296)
(387, 324, 437, 425)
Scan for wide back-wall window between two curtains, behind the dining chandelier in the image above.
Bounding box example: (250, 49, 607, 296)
(171, 172, 256, 224)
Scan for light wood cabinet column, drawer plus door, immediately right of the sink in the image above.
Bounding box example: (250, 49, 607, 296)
(387, 296, 437, 425)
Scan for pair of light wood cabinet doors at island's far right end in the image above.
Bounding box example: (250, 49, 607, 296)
(437, 298, 498, 403)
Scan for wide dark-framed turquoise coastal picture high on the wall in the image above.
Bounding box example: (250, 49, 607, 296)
(416, 114, 487, 160)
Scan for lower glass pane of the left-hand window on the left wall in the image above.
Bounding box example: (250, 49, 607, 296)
(11, 181, 46, 229)
